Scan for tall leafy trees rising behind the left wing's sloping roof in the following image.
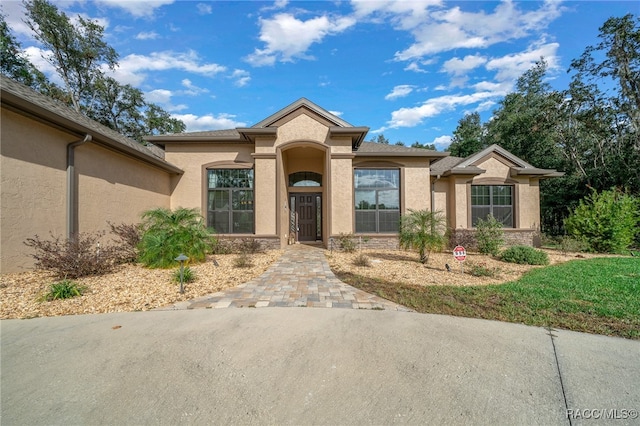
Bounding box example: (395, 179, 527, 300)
(19, 0, 186, 143)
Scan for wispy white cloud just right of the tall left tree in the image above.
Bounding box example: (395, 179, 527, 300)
(113, 50, 226, 87)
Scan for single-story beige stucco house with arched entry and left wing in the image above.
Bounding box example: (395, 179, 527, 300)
(1, 77, 558, 272)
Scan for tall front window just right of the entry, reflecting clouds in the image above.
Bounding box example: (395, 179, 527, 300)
(354, 169, 400, 233)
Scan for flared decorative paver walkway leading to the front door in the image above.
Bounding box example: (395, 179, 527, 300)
(161, 244, 411, 312)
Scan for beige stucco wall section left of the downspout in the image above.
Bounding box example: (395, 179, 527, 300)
(0, 109, 68, 273)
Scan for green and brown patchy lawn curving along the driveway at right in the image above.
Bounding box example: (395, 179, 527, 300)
(337, 258, 640, 339)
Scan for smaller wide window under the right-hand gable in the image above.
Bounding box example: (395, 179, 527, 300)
(471, 185, 513, 228)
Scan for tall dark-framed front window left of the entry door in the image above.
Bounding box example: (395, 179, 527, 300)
(207, 169, 253, 234)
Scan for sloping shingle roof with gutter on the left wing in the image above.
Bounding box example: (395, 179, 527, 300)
(0, 75, 183, 173)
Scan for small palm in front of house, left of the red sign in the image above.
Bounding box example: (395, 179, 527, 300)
(399, 210, 446, 264)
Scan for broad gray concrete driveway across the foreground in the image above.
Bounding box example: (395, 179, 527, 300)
(0, 308, 640, 426)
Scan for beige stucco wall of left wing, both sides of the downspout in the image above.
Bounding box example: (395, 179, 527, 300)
(0, 109, 171, 273)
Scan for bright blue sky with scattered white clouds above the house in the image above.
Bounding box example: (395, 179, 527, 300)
(2, 0, 640, 150)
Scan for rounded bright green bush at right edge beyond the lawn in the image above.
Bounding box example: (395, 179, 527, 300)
(565, 189, 640, 253)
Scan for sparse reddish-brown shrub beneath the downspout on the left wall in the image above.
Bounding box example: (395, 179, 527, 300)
(24, 232, 120, 279)
